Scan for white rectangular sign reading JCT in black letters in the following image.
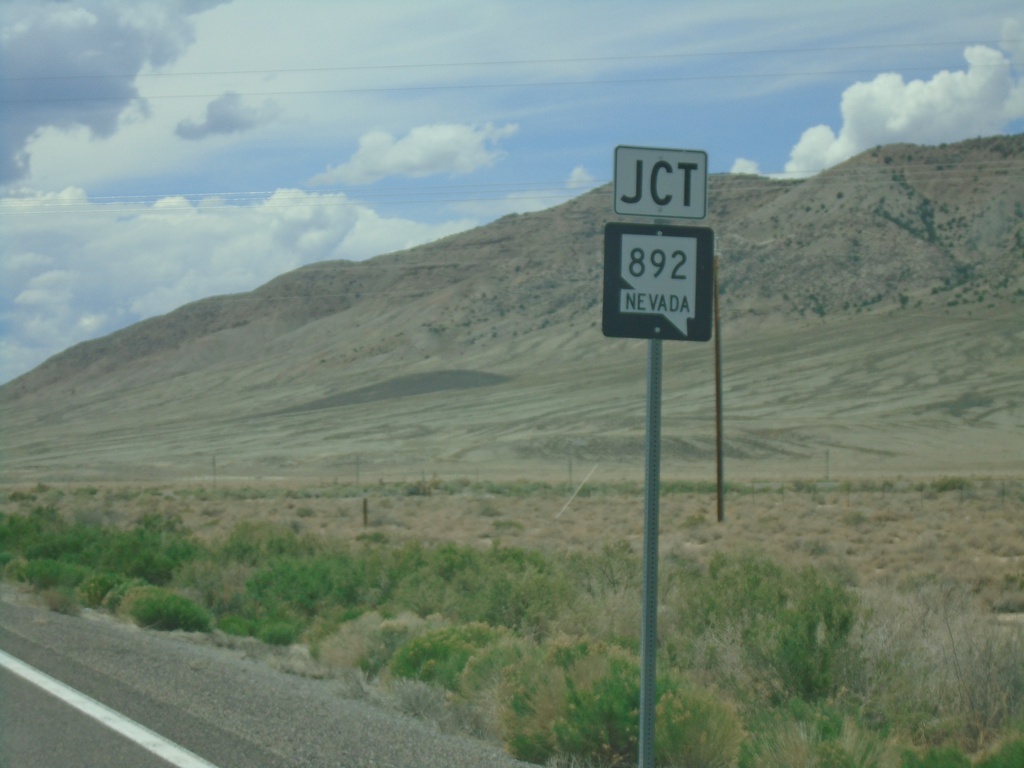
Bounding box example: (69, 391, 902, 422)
(614, 146, 708, 219)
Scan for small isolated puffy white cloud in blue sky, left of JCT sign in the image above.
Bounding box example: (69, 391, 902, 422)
(309, 123, 519, 186)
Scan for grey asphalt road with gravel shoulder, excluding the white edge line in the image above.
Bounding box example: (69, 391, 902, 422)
(0, 589, 524, 768)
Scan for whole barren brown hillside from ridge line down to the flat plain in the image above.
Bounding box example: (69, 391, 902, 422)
(0, 136, 1024, 479)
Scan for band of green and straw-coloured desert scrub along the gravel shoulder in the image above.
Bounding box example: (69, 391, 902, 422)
(0, 501, 1024, 768)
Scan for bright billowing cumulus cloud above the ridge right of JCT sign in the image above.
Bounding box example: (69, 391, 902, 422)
(785, 45, 1024, 175)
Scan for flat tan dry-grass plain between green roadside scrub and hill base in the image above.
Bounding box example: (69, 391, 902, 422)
(9, 477, 1024, 621)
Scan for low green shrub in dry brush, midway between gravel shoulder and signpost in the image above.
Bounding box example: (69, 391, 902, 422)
(388, 623, 503, 691)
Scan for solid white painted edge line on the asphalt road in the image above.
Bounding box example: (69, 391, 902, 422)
(0, 650, 217, 768)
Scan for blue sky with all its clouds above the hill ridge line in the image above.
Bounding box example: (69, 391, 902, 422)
(0, 0, 1024, 382)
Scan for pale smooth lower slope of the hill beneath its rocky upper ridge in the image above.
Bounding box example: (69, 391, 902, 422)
(0, 302, 1024, 483)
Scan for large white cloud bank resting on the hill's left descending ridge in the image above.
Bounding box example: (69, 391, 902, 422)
(0, 189, 478, 381)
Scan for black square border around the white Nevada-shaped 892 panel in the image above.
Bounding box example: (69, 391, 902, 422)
(601, 221, 715, 341)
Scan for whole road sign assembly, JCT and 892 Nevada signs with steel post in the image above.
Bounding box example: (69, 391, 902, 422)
(601, 146, 717, 768)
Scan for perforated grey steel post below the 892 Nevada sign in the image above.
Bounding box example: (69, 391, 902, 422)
(639, 339, 662, 768)
